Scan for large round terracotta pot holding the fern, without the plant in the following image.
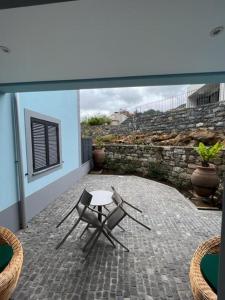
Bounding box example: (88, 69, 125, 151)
(191, 164, 219, 197)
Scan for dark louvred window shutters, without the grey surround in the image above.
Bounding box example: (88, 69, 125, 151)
(31, 118, 60, 172)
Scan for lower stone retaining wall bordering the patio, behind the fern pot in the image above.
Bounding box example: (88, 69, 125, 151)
(105, 144, 225, 187)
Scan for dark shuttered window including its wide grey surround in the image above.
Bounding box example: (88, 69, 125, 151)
(25, 110, 61, 180)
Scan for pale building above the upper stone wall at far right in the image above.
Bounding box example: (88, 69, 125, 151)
(187, 83, 225, 107)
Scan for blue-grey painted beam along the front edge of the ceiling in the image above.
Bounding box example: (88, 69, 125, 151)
(0, 72, 225, 93)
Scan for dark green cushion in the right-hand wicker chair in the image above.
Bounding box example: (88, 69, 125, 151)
(200, 254, 219, 293)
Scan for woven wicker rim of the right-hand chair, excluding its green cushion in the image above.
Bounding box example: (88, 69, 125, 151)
(189, 236, 220, 300)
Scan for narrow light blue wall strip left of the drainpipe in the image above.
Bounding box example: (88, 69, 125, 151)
(0, 94, 17, 211)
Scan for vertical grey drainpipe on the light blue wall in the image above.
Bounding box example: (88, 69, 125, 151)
(11, 94, 27, 229)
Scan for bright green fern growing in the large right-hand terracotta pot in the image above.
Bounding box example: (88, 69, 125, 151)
(196, 142, 223, 167)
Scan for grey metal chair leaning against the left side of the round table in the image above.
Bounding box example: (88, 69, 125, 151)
(55, 189, 101, 249)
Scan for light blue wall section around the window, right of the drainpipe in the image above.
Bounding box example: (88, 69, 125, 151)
(17, 91, 79, 196)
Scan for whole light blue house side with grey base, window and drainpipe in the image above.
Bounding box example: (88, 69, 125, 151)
(0, 91, 89, 231)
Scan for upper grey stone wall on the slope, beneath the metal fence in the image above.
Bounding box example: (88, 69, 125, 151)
(82, 101, 225, 137)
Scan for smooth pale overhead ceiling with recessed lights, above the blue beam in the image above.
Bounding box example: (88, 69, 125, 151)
(0, 0, 225, 88)
